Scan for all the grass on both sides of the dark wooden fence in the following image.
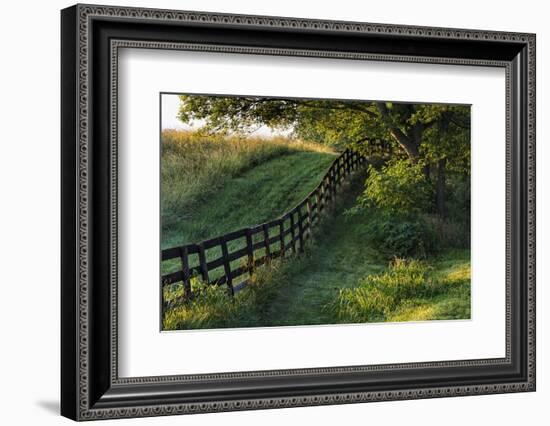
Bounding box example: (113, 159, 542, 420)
(162, 131, 470, 329)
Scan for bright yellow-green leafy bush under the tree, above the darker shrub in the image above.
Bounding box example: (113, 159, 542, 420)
(359, 159, 430, 217)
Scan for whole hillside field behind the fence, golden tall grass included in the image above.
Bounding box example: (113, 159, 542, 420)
(161, 130, 337, 248)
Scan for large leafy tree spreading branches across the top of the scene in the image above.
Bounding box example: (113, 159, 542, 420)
(179, 95, 470, 217)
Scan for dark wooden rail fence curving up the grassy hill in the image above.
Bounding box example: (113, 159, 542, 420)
(161, 149, 366, 299)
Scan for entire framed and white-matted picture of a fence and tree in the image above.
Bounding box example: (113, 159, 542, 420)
(61, 5, 535, 420)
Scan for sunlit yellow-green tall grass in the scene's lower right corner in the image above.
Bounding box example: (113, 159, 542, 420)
(331, 259, 470, 323)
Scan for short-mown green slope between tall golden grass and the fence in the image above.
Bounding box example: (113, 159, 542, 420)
(162, 151, 336, 247)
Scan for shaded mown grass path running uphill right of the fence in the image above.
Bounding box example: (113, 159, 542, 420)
(261, 179, 386, 325)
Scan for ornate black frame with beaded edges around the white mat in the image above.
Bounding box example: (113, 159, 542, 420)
(61, 5, 535, 420)
